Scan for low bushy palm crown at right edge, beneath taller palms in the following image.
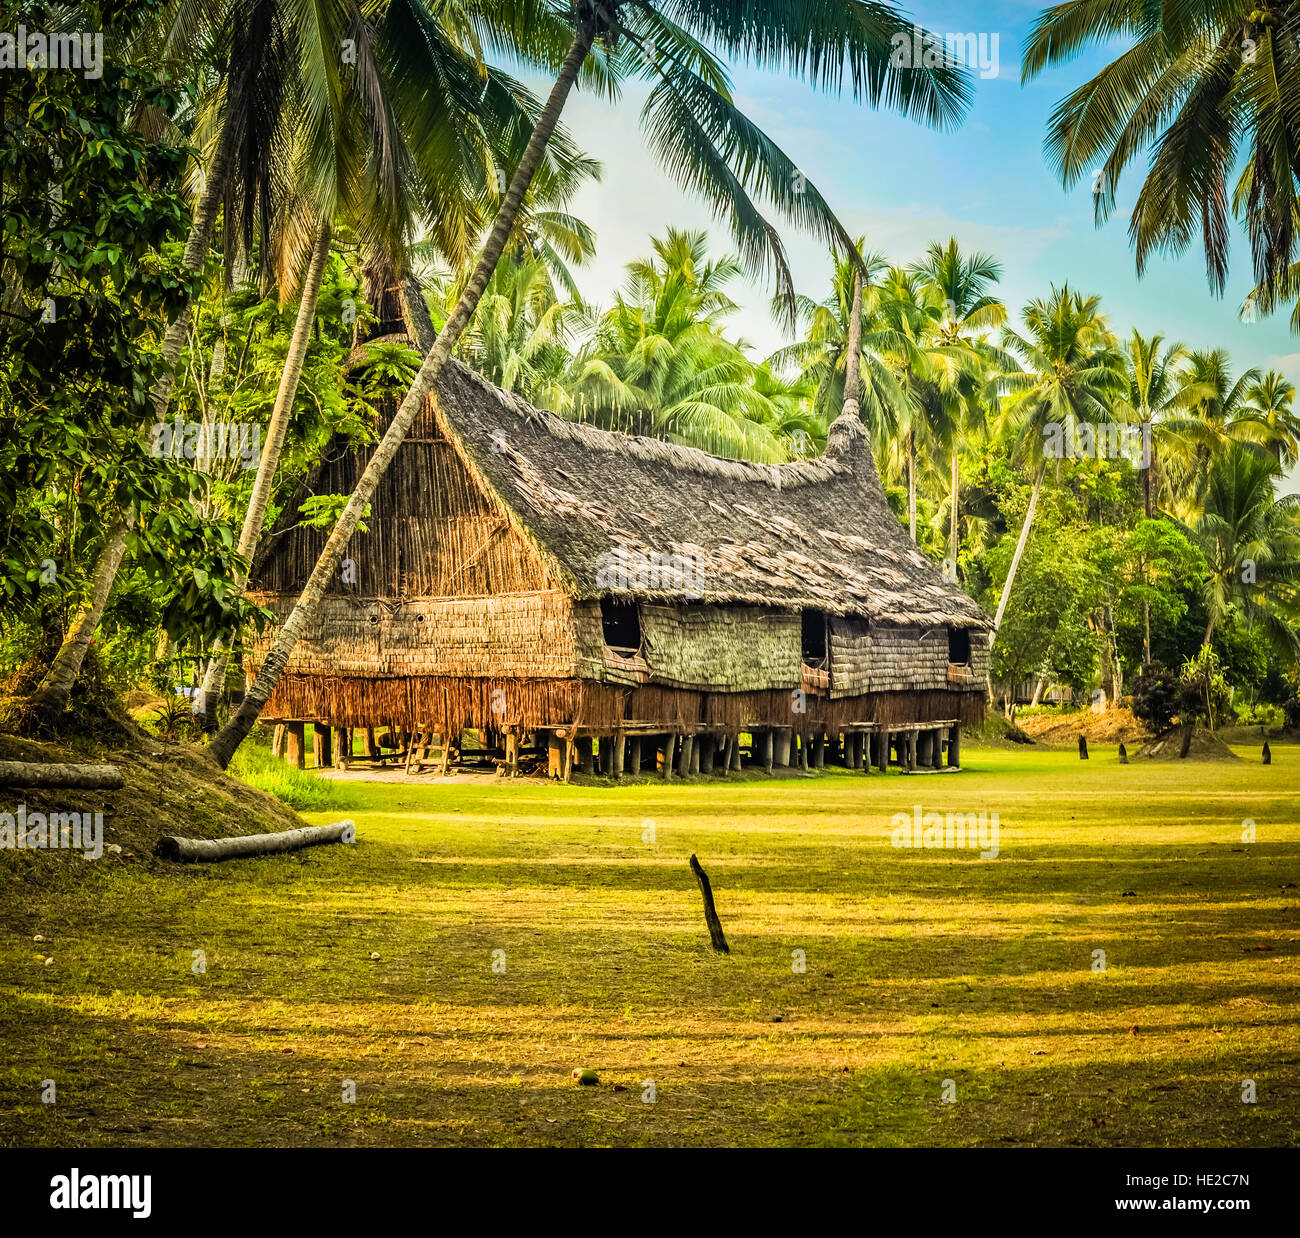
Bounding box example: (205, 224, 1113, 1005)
(1192, 443, 1300, 655)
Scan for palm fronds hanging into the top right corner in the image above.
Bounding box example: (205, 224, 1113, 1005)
(1022, 0, 1300, 293)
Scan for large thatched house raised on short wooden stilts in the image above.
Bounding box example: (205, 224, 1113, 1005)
(246, 318, 991, 779)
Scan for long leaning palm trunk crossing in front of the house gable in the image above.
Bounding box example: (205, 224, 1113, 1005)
(211, 23, 594, 769)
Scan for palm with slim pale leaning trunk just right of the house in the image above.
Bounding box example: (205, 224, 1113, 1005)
(993, 285, 1123, 632)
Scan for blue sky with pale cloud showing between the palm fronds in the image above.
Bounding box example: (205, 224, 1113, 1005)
(517, 0, 1300, 489)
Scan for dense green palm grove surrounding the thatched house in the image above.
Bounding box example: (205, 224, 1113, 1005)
(0, 0, 1300, 761)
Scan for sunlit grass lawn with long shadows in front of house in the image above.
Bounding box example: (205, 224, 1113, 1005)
(0, 745, 1300, 1146)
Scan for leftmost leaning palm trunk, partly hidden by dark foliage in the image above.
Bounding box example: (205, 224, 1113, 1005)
(33, 115, 235, 726)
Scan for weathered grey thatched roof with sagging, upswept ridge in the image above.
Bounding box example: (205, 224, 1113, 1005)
(431, 362, 991, 627)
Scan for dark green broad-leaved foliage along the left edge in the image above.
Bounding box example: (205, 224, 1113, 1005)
(0, 3, 258, 658)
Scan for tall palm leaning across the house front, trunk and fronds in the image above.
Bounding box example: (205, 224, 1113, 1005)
(212, 0, 970, 766)
